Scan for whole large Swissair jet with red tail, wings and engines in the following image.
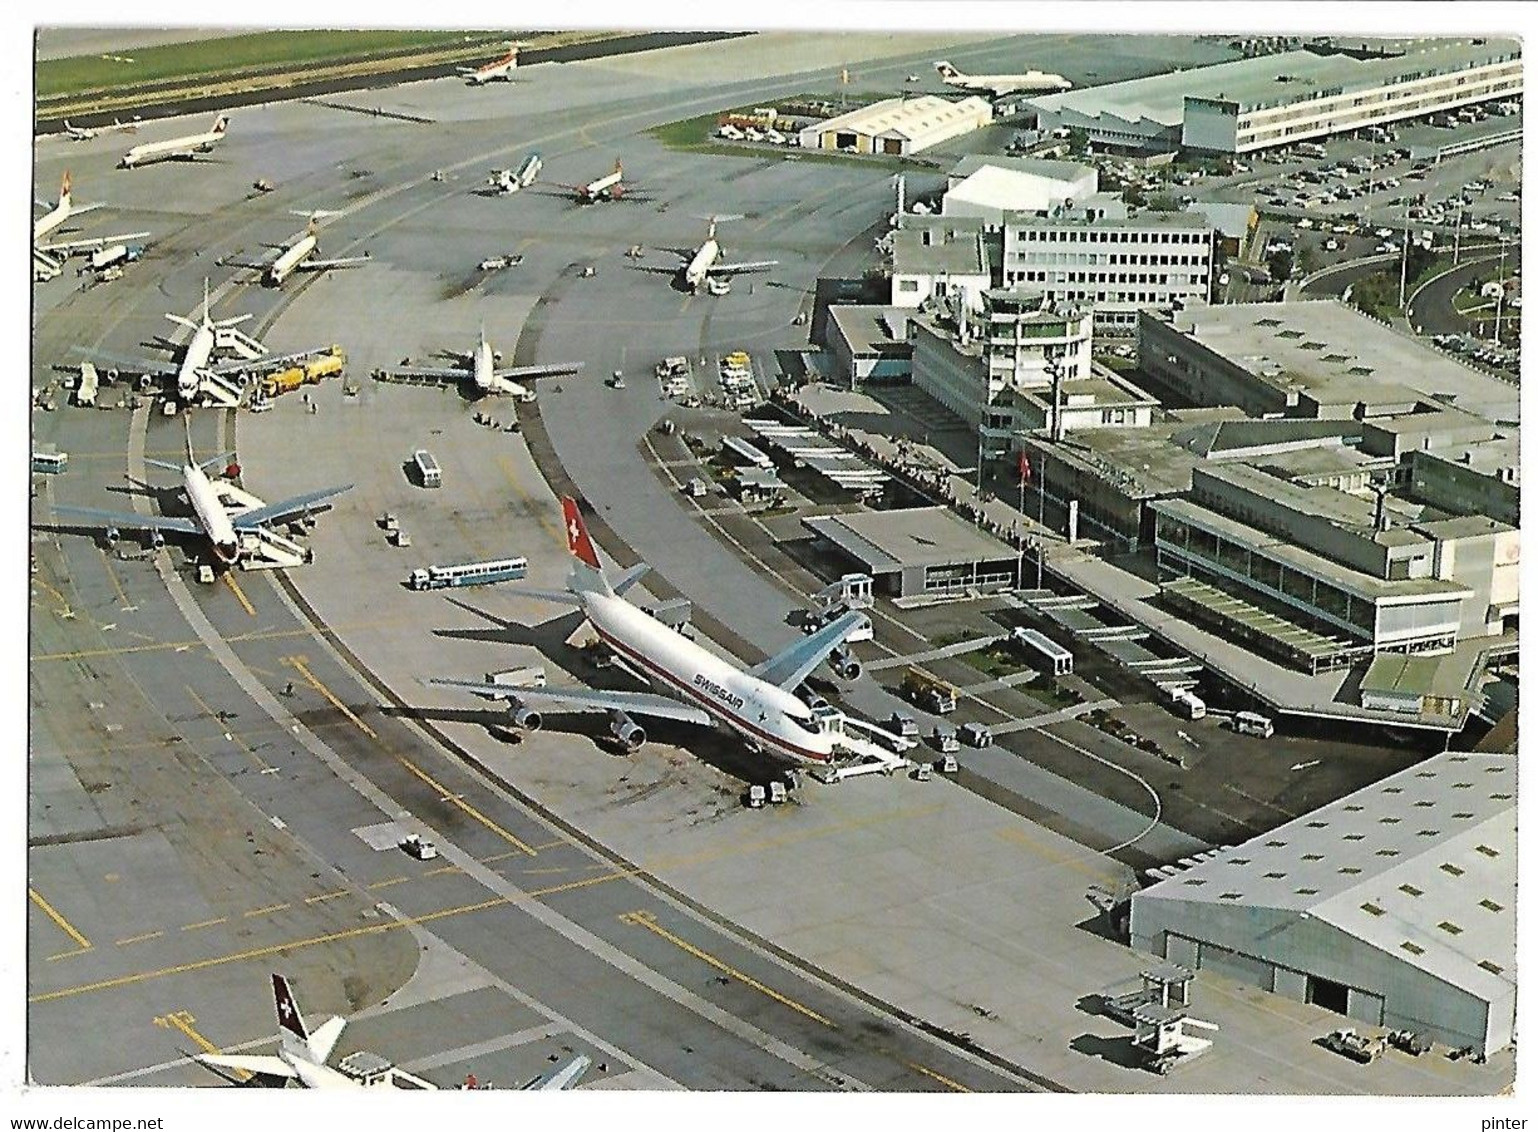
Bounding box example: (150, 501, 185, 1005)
(429, 498, 895, 763)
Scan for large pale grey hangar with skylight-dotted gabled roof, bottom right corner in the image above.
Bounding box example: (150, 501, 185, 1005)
(1132, 752, 1516, 1057)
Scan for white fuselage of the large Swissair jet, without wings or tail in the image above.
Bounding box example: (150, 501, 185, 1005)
(581, 592, 834, 763)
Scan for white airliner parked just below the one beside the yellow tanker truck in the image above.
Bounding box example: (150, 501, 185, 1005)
(54, 426, 352, 566)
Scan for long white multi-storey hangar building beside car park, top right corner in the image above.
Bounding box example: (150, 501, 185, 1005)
(1030, 40, 1523, 154)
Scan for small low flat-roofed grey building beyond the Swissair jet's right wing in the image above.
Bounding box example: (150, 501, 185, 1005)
(801, 506, 1020, 597)
